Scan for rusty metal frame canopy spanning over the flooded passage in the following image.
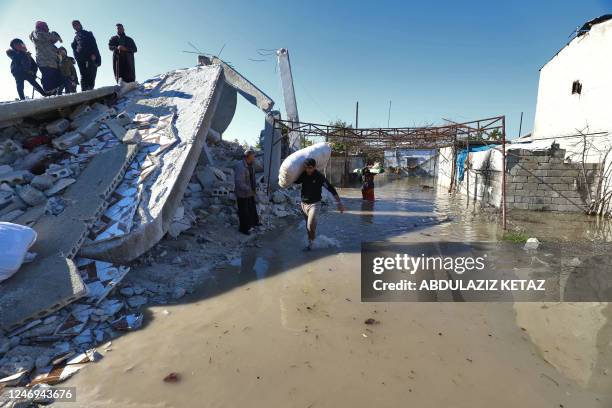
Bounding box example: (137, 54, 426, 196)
(268, 116, 506, 230)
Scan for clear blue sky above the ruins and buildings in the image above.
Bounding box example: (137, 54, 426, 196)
(0, 0, 612, 144)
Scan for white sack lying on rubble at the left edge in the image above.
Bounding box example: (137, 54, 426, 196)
(0, 222, 36, 282)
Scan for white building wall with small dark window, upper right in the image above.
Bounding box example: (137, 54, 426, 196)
(533, 20, 612, 161)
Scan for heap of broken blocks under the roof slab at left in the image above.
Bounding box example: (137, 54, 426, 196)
(0, 103, 124, 223)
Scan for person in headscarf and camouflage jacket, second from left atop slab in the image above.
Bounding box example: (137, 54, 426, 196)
(30, 21, 62, 93)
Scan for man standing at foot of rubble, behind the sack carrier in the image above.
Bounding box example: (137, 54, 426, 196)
(234, 150, 261, 235)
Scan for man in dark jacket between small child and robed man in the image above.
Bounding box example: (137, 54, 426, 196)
(72, 20, 102, 91)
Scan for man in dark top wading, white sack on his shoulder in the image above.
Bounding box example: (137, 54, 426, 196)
(295, 158, 344, 251)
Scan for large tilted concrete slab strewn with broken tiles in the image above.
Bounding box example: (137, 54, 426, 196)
(80, 65, 224, 263)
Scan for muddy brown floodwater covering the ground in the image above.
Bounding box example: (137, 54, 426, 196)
(58, 179, 612, 408)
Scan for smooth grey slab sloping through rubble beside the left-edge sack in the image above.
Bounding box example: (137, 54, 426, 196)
(0, 144, 136, 330)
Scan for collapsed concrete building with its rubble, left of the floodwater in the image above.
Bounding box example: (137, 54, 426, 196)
(0, 57, 306, 388)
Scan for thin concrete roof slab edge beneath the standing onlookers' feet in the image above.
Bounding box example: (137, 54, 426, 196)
(0, 85, 120, 127)
